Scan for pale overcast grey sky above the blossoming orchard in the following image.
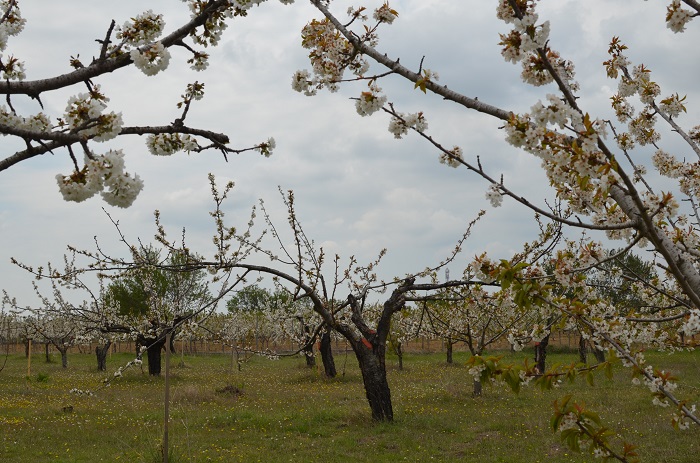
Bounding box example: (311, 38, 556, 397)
(0, 0, 700, 305)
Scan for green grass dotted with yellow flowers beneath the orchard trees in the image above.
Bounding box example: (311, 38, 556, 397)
(0, 353, 700, 463)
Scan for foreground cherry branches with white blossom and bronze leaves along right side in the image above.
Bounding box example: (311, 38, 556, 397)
(292, 0, 700, 461)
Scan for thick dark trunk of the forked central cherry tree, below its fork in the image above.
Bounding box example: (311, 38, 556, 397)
(355, 344, 394, 421)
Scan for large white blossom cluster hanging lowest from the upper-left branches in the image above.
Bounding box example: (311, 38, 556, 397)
(56, 150, 143, 207)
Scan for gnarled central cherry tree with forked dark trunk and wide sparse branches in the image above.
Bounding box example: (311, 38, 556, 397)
(23, 175, 479, 421)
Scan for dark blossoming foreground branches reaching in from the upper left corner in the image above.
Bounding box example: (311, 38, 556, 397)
(0, 0, 293, 207)
